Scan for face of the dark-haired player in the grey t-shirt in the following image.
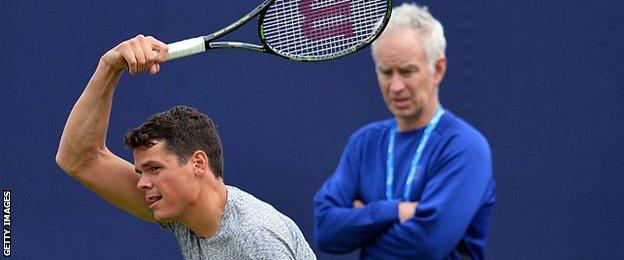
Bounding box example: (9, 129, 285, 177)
(133, 142, 199, 221)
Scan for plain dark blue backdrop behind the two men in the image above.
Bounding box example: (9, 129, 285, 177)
(0, 0, 624, 259)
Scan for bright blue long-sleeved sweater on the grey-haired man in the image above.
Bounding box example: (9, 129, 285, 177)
(314, 111, 495, 259)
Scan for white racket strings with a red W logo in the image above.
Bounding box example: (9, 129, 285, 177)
(262, 0, 388, 59)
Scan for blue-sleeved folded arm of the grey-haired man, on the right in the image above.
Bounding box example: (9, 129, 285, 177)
(367, 136, 492, 259)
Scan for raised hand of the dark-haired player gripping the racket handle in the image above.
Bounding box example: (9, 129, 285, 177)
(100, 34, 168, 75)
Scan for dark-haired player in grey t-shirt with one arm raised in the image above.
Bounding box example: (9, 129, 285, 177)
(56, 35, 316, 259)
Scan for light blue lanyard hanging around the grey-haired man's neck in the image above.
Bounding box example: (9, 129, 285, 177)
(386, 107, 444, 201)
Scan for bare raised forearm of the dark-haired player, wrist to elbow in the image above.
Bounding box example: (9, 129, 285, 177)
(56, 61, 123, 174)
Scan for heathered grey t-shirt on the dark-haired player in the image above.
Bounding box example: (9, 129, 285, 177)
(165, 186, 316, 260)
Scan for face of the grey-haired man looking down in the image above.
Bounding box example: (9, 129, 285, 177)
(373, 28, 446, 128)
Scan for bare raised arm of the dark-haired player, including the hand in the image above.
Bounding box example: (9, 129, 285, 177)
(56, 35, 167, 222)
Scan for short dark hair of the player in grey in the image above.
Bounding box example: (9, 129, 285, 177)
(124, 106, 223, 178)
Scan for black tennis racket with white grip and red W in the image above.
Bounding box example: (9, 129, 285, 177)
(167, 0, 392, 61)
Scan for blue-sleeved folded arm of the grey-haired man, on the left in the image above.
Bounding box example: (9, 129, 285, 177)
(314, 136, 399, 254)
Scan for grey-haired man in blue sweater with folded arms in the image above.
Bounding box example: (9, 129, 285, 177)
(314, 4, 495, 259)
